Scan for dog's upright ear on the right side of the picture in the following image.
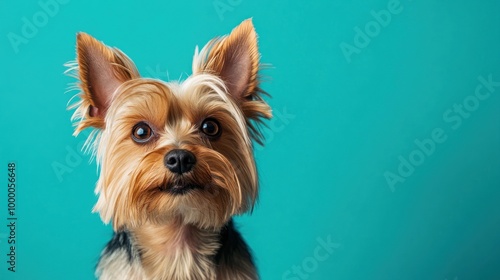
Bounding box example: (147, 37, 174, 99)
(193, 19, 272, 142)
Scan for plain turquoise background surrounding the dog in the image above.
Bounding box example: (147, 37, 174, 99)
(0, 0, 500, 280)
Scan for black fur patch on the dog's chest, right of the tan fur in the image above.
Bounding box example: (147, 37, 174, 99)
(214, 219, 255, 268)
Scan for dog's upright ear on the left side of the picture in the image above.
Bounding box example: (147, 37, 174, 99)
(69, 33, 139, 132)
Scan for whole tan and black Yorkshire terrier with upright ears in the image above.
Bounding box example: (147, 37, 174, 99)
(68, 19, 271, 280)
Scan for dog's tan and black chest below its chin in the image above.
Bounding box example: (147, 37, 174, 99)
(97, 221, 258, 280)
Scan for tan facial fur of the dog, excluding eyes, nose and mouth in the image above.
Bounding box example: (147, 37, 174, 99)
(94, 76, 257, 229)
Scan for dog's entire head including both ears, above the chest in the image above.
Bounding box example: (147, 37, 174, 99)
(68, 20, 271, 229)
